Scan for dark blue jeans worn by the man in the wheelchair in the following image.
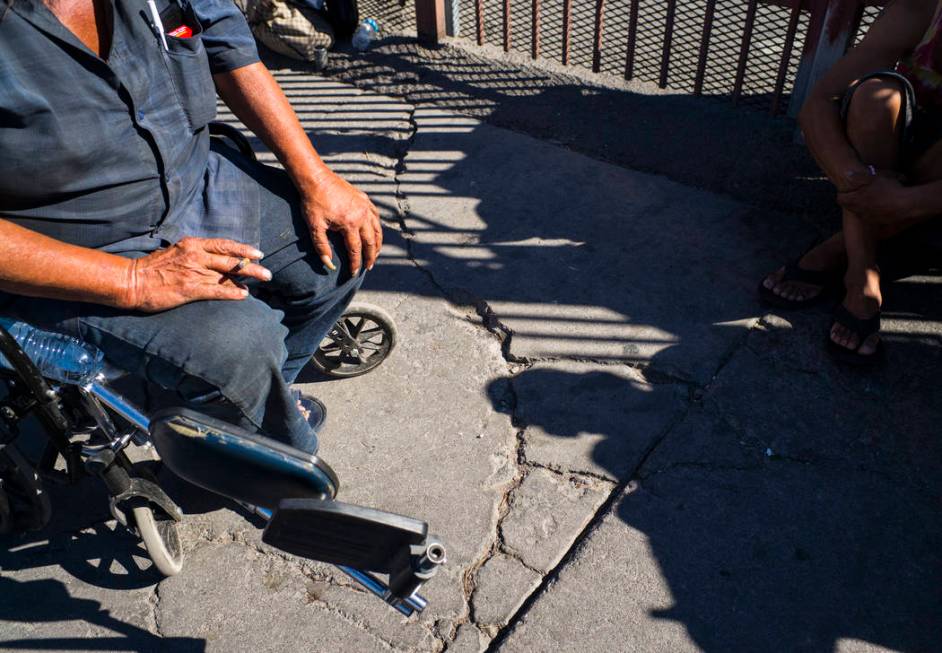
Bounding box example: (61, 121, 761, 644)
(0, 154, 363, 453)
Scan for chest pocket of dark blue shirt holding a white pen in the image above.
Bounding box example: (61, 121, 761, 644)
(166, 3, 216, 132)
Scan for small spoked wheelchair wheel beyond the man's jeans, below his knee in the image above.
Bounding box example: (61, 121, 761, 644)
(311, 303, 398, 378)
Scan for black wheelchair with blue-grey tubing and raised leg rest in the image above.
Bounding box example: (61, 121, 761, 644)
(0, 123, 446, 617)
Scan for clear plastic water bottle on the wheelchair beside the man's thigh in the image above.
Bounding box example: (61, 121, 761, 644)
(0, 318, 104, 384)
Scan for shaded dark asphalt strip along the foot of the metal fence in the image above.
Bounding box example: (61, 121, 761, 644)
(262, 37, 839, 224)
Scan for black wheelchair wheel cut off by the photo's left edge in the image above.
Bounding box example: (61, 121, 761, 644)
(0, 444, 52, 533)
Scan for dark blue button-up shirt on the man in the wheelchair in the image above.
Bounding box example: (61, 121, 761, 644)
(0, 0, 258, 253)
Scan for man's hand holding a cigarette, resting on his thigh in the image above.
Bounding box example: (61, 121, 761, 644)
(119, 238, 271, 313)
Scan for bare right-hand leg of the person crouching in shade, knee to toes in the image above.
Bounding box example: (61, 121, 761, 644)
(831, 79, 903, 355)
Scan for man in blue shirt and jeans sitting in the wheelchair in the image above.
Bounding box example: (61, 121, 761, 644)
(0, 0, 382, 452)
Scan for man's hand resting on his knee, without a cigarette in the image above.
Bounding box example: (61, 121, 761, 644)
(301, 171, 383, 276)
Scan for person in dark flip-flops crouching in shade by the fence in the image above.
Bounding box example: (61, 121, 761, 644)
(759, 0, 942, 364)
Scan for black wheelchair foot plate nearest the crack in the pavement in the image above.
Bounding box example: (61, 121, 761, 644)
(262, 499, 445, 598)
